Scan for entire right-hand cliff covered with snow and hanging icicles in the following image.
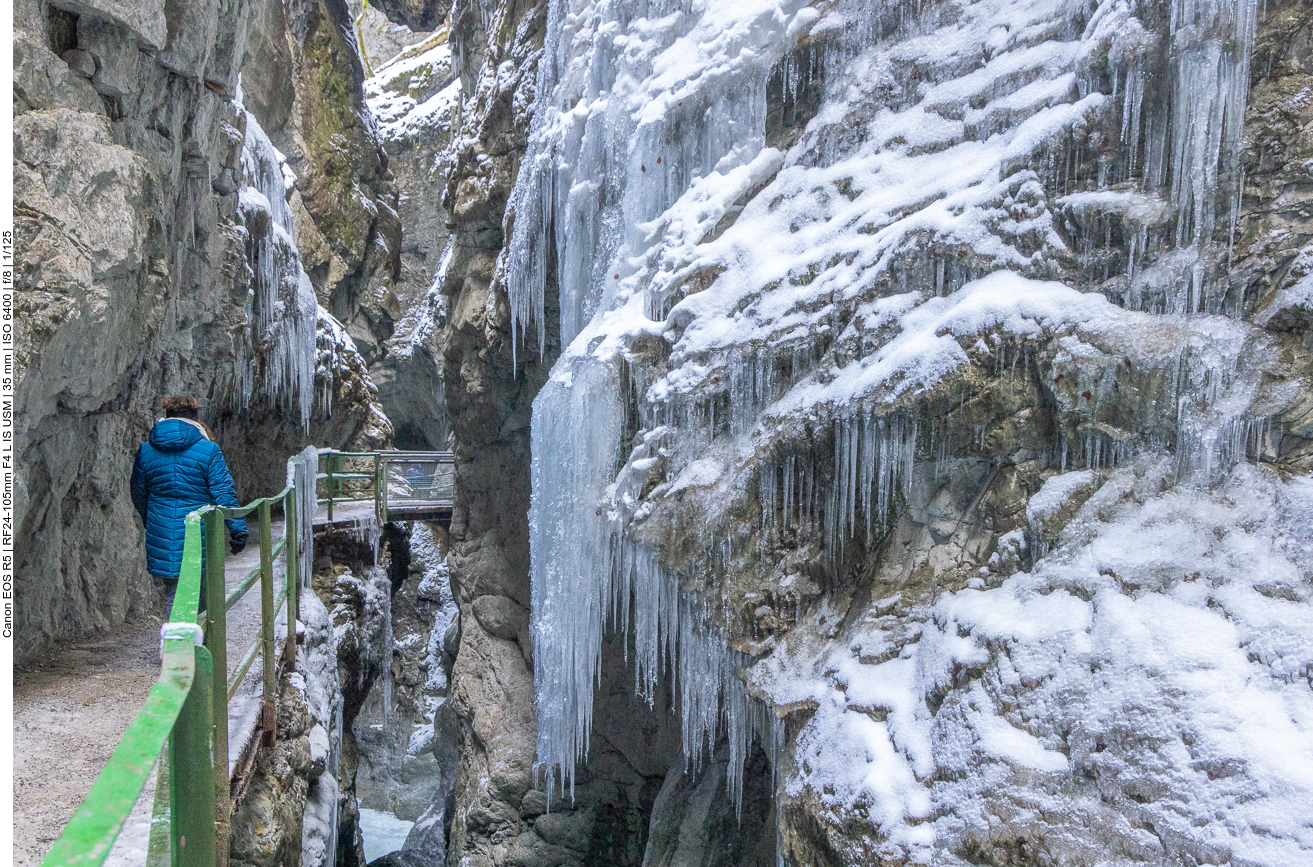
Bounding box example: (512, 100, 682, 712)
(425, 1, 1313, 864)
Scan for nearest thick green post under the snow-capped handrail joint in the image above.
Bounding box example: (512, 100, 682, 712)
(169, 646, 216, 867)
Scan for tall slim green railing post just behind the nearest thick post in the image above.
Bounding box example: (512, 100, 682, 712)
(205, 508, 232, 866)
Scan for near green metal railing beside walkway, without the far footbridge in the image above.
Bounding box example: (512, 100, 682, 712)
(42, 449, 315, 867)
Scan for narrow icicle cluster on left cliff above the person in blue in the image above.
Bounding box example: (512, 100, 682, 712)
(236, 112, 319, 428)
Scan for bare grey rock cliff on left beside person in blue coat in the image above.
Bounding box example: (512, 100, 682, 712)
(14, 1, 399, 656)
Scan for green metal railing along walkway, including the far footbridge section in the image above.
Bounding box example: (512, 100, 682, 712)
(42, 449, 454, 867)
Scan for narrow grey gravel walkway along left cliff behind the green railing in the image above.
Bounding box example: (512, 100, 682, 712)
(13, 510, 301, 867)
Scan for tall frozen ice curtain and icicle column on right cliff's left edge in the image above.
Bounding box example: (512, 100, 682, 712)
(519, 3, 815, 796)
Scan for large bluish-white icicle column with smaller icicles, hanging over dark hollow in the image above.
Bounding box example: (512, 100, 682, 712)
(529, 360, 775, 801)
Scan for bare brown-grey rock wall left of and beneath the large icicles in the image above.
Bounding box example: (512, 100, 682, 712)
(425, 4, 773, 867)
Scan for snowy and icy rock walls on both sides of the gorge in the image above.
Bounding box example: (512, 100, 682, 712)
(16, 0, 1313, 867)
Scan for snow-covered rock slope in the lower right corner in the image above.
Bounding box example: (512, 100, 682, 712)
(750, 457, 1313, 866)
